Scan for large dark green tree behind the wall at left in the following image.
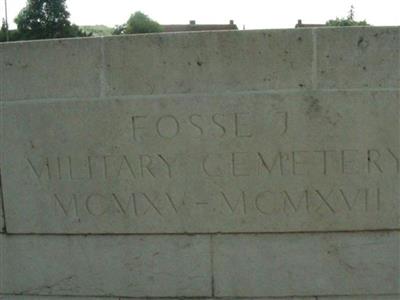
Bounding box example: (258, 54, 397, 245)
(15, 0, 87, 40)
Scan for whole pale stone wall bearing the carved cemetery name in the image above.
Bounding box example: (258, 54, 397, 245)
(0, 27, 400, 300)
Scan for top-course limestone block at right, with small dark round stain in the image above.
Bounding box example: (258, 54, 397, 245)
(316, 27, 400, 89)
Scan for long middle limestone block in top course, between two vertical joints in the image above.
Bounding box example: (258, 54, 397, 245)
(104, 30, 313, 95)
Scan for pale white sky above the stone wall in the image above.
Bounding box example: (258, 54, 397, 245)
(0, 0, 400, 29)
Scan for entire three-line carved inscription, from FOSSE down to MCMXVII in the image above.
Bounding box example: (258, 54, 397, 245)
(14, 98, 400, 232)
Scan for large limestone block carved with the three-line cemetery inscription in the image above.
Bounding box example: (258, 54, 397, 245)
(1, 91, 400, 233)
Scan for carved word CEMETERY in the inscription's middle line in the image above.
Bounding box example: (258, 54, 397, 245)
(201, 148, 400, 177)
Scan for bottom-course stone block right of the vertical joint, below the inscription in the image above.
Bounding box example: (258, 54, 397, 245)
(213, 232, 400, 298)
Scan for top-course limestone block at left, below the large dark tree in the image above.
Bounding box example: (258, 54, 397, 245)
(0, 38, 102, 101)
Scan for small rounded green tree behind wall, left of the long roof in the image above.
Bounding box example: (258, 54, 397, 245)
(113, 11, 162, 34)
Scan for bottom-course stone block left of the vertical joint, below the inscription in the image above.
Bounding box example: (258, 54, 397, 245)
(1, 235, 211, 297)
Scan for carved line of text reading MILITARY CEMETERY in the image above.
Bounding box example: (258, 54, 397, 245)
(26, 148, 400, 181)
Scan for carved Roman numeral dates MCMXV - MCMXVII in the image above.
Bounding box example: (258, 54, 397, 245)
(51, 187, 382, 218)
